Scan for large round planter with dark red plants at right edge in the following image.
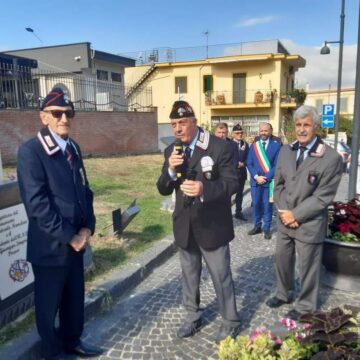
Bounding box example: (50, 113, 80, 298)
(322, 199, 360, 291)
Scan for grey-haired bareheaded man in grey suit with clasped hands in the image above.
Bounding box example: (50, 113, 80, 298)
(266, 105, 342, 320)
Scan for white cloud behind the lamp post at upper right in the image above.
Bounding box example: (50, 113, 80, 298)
(281, 40, 357, 90)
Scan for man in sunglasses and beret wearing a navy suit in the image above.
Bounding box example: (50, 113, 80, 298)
(17, 88, 101, 360)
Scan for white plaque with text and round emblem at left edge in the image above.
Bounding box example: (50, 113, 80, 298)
(0, 204, 34, 300)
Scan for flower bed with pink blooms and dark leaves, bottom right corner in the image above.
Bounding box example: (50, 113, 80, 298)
(219, 305, 360, 360)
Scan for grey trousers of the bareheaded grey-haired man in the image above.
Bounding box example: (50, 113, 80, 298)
(275, 231, 323, 313)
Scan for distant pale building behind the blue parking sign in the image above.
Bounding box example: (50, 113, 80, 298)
(305, 88, 355, 119)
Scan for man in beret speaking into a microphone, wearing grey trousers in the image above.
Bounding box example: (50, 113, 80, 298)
(157, 101, 240, 342)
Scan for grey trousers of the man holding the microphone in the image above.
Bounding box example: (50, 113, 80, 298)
(179, 240, 240, 326)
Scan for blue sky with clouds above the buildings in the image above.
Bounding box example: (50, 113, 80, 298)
(0, 0, 360, 89)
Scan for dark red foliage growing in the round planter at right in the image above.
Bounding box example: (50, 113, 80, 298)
(329, 199, 360, 243)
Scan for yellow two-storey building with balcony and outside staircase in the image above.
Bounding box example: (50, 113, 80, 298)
(125, 40, 305, 144)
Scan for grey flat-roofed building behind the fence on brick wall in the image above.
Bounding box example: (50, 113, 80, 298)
(6, 42, 138, 111)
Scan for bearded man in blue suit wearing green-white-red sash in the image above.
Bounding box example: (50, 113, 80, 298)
(247, 123, 281, 239)
